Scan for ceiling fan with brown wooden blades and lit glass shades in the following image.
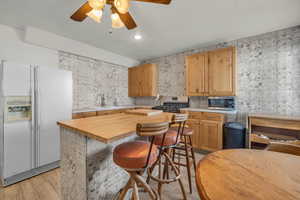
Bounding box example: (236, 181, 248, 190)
(71, 0, 172, 30)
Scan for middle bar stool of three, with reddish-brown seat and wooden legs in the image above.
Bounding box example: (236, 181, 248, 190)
(147, 114, 187, 199)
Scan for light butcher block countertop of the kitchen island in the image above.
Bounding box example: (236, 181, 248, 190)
(57, 113, 173, 144)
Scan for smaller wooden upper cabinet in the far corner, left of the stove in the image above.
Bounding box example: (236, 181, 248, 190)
(128, 64, 157, 97)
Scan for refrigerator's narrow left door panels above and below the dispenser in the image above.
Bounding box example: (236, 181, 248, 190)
(1, 61, 34, 178)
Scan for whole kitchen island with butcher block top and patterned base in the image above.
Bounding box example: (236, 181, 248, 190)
(58, 113, 173, 200)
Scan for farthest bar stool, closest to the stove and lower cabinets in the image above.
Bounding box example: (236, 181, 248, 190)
(169, 117, 196, 194)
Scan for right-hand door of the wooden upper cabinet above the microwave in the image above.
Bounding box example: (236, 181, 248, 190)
(208, 47, 236, 96)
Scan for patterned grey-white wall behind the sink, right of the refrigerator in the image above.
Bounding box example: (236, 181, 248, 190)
(59, 52, 134, 110)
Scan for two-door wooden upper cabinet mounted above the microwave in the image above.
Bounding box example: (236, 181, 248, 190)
(185, 47, 236, 96)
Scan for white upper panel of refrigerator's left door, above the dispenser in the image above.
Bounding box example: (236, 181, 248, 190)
(3, 61, 31, 96)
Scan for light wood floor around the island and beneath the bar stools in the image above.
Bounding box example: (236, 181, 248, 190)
(0, 153, 203, 200)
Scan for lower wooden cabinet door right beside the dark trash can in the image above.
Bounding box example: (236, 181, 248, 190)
(200, 120, 223, 151)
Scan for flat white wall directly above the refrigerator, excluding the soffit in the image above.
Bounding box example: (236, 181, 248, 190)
(0, 25, 58, 67)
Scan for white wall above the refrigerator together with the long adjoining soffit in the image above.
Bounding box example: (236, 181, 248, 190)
(0, 24, 140, 67)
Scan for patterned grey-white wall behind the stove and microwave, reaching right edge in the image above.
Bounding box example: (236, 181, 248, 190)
(136, 26, 300, 121)
